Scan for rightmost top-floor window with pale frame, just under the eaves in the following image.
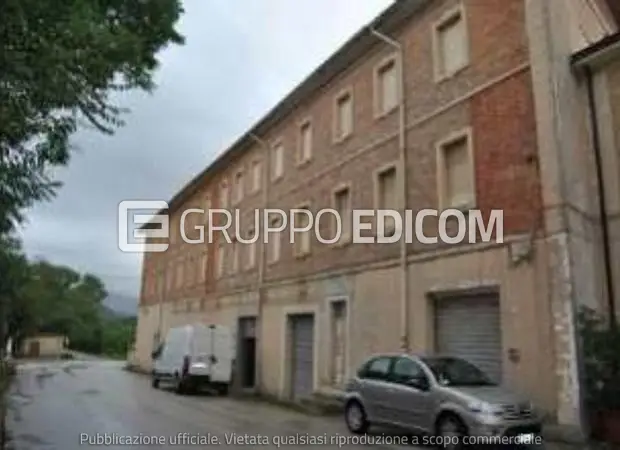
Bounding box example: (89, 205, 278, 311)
(434, 6, 469, 80)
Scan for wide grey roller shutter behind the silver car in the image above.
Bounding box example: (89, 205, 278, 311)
(435, 295, 502, 382)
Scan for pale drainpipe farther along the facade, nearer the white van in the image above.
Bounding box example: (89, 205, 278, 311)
(250, 133, 271, 390)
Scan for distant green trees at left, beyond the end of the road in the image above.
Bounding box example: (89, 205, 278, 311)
(0, 247, 135, 357)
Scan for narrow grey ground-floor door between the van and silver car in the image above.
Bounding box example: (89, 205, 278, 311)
(291, 315, 314, 399)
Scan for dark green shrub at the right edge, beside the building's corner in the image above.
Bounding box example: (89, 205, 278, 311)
(578, 308, 620, 411)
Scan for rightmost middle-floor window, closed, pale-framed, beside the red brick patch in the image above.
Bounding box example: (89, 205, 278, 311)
(437, 131, 475, 210)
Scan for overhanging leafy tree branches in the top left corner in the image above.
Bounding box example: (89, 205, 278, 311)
(0, 0, 183, 230)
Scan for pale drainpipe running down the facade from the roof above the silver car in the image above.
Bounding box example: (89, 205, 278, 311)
(369, 26, 410, 352)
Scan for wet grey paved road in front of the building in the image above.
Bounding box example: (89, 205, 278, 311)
(7, 361, 414, 450)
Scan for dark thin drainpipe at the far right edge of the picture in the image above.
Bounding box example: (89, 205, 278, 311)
(584, 66, 618, 330)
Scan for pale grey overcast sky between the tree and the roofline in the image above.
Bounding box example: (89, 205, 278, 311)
(23, 0, 391, 306)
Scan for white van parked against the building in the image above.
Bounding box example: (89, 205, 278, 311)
(152, 324, 235, 395)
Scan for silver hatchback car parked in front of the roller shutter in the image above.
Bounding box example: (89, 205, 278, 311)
(345, 354, 542, 448)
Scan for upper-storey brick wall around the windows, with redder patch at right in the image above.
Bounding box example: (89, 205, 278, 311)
(138, 0, 540, 302)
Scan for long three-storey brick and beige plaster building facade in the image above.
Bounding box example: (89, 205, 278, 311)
(135, 0, 620, 436)
